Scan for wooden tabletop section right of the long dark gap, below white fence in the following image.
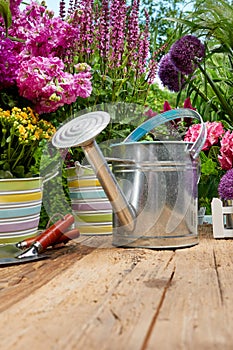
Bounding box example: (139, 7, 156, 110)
(145, 235, 233, 350)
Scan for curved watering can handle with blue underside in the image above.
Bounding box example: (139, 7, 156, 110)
(124, 108, 206, 158)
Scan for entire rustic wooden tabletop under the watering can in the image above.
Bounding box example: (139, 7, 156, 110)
(0, 225, 233, 350)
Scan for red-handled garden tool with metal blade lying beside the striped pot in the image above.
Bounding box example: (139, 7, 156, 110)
(0, 214, 79, 266)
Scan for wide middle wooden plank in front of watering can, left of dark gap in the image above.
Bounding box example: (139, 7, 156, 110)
(0, 248, 173, 350)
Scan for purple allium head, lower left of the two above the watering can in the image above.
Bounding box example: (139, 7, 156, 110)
(158, 53, 185, 92)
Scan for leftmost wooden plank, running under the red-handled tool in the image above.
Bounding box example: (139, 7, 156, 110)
(0, 237, 105, 312)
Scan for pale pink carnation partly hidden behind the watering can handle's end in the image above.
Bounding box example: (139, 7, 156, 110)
(184, 122, 224, 151)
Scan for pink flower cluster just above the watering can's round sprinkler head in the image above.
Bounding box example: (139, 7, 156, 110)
(16, 56, 92, 114)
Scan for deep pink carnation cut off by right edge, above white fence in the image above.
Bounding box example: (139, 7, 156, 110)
(218, 131, 233, 170)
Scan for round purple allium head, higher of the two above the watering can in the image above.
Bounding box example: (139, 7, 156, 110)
(169, 35, 205, 74)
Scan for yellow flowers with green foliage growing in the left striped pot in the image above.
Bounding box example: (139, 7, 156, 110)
(0, 107, 56, 176)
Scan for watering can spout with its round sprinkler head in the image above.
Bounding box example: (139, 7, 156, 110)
(52, 111, 136, 232)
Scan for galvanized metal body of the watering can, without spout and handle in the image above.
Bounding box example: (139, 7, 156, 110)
(112, 141, 198, 248)
